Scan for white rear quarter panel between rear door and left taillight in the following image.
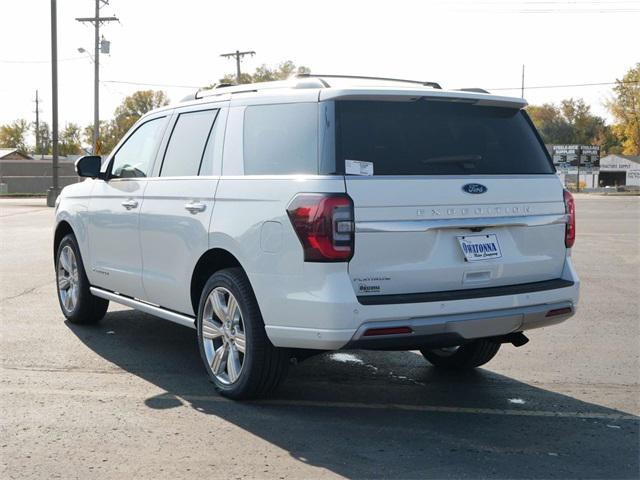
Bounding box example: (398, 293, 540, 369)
(209, 176, 348, 325)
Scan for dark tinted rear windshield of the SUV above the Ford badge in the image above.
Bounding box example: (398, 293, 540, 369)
(336, 99, 554, 175)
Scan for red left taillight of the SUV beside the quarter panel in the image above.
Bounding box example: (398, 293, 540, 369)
(287, 193, 354, 262)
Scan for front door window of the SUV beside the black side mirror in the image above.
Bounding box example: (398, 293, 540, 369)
(111, 117, 167, 178)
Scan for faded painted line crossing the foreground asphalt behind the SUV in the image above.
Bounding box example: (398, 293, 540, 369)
(0, 387, 640, 421)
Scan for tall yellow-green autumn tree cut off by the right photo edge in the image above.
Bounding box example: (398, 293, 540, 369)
(607, 63, 640, 155)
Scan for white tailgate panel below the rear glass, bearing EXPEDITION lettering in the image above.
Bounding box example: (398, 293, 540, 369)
(346, 176, 566, 296)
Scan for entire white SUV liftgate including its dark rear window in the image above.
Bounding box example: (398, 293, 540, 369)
(335, 98, 566, 296)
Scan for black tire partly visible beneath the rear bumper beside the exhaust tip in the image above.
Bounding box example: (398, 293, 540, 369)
(420, 339, 500, 370)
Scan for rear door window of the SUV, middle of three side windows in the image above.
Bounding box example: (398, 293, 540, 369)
(160, 110, 218, 177)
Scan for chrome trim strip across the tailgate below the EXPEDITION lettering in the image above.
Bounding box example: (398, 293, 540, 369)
(356, 213, 569, 233)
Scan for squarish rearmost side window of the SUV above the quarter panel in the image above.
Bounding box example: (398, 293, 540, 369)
(243, 103, 318, 175)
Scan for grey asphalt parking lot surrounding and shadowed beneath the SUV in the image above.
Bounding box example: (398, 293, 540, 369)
(0, 195, 640, 479)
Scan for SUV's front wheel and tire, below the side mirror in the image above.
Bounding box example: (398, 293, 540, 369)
(56, 233, 109, 324)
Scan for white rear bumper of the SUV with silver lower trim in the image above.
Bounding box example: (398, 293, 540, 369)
(258, 257, 580, 350)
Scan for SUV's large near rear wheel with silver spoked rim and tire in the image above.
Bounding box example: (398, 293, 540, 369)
(196, 268, 289, 400)
